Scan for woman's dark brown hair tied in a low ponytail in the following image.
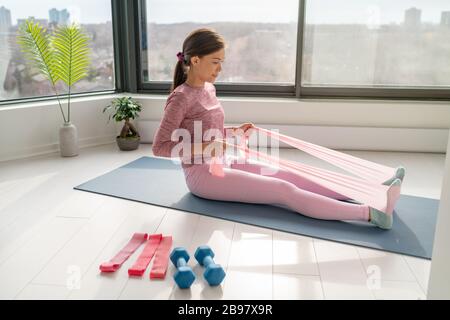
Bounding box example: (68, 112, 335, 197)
(170, 28, 225, 92)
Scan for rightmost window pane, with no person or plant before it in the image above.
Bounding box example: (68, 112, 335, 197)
(302, 0, 450, 88)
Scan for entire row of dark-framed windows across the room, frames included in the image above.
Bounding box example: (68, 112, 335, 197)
(0, 0, 450, 104)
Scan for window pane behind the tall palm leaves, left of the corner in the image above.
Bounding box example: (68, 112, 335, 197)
(0, 0, 115, 101)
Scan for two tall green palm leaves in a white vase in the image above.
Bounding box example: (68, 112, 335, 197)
(17, 19, 90, 157)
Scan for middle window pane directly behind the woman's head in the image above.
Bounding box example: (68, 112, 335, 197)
(141, 0, 299, 85)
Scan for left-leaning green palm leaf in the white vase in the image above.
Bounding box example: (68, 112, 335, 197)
(17, 20, 66, 121)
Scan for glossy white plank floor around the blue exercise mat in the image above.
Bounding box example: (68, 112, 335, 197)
(0, 144, 445, 299)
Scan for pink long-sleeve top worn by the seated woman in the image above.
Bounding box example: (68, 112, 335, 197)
(152, 82, 232, 168)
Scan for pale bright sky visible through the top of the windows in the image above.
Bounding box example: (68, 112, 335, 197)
(0, 0, 450, 24)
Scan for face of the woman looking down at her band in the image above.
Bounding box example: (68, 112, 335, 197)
(192, 49, 225, 83)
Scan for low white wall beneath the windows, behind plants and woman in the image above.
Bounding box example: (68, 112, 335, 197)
(0, 94, 450, 161)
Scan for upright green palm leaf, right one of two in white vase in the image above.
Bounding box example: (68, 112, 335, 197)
(52, 24, 90, 121)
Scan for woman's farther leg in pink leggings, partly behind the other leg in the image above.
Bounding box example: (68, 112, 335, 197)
(230, 157, 351, 200)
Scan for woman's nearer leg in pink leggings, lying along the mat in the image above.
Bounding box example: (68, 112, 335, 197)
(187, 166, 369, 221)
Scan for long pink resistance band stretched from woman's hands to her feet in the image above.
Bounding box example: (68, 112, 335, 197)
(209, 127, 395, 211)
